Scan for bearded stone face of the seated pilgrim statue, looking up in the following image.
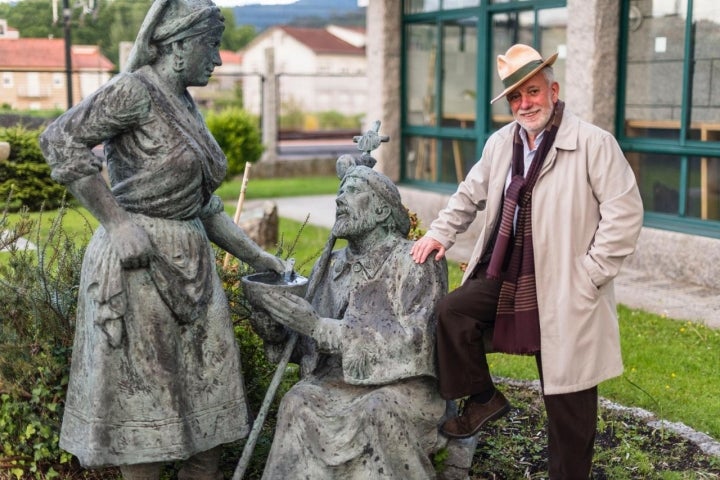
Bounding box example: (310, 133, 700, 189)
(333, 177, 376, 238)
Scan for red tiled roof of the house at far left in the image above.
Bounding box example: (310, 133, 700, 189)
(0, 38, 114, 71)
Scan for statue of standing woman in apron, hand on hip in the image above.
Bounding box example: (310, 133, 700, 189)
(41, 0, 284, 480)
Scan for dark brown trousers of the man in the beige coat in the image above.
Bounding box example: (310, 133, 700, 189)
(437, 268, 598, 480)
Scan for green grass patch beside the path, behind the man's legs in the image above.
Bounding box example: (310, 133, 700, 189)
(488, 305, 720, 439)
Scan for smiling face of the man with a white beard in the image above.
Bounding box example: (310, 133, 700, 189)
(505, 72, 560, 138)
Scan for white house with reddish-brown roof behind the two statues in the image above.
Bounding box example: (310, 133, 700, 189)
(242, 26, 368, 115)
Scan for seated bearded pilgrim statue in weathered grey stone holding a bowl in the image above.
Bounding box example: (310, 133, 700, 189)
(256, 156, 447, 480)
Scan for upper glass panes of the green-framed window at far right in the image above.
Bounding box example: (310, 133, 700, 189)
(625, 0, 720, 141)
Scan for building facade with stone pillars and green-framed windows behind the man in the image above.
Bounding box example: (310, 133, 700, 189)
(367, 0, 720, 287)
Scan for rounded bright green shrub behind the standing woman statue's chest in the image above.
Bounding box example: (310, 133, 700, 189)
(206, 107, 263, 178)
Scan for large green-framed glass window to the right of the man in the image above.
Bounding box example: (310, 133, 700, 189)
(618, 0, 720, 235)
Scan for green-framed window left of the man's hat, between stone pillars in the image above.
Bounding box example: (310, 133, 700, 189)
(400, 0, 567, 193)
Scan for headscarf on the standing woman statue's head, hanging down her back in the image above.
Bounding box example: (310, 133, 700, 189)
(125, 0, 224, 72)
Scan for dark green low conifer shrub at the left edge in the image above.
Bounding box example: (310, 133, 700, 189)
(0, 125, 66, 212)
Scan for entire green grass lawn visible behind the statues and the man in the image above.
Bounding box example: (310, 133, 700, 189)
(0, 177, 720, 439)
